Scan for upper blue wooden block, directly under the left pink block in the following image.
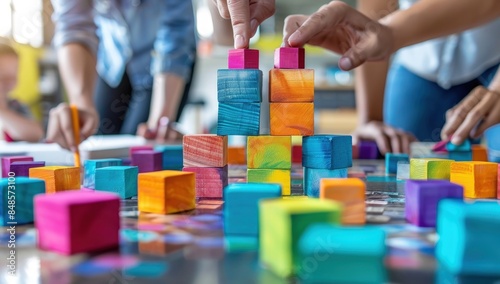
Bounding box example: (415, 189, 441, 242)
(217, 69, 262, 103)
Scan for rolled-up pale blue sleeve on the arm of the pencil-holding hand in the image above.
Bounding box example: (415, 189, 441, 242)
(52, 0, 98, 54)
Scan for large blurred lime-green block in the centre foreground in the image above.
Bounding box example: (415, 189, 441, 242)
(259, 198, 342, 277)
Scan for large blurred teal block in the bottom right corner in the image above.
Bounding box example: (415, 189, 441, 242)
(436, 199, 500, 275)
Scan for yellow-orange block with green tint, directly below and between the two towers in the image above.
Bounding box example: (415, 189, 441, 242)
(247, 136, 292, 170)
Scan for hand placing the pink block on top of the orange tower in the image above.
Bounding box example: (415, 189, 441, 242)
(283, 1, 394, 70)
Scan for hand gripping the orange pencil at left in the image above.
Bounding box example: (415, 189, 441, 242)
(47, 103, 99, 152)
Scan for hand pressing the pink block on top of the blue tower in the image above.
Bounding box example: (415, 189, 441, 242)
(213, 0, 275, 48)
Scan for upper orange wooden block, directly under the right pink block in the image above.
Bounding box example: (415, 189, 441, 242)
(269, 69, 314, 103)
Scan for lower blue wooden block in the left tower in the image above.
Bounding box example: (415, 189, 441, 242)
(217, 103, 260, 136)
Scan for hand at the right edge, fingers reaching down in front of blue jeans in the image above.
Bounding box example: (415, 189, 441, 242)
(441, 86, 500, 145)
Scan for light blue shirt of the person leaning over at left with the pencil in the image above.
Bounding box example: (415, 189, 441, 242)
(52, 0, 196, 88)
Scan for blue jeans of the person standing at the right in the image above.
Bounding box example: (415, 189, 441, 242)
(384, 63, 499, 142)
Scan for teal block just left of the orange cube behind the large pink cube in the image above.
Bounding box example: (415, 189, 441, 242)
(95, 166, 139, 199)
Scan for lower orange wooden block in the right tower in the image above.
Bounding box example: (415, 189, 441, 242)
(270, 103, 314, 136)
